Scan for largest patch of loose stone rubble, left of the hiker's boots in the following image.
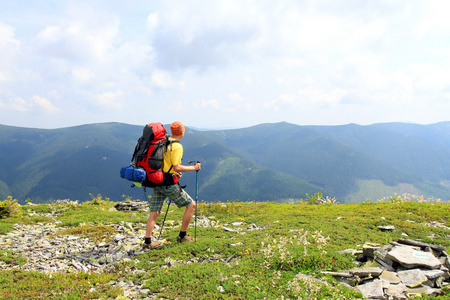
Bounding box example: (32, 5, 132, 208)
(0, 222, 145, 273)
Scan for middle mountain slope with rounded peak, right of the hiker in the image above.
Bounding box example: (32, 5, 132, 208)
(204, 123, 426, 199)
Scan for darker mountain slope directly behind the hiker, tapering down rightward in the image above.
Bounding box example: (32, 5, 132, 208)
(0, 123, 320, 203)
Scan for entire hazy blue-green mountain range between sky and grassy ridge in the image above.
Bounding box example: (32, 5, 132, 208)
(0, 122, 450, 203)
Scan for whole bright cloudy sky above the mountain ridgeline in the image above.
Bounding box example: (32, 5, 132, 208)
(0, 0, 450, 129)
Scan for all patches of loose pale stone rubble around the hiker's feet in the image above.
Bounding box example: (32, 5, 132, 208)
(0, 202, 264, 299)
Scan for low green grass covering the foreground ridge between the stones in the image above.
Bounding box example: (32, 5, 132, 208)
(0, 197, 450, 299)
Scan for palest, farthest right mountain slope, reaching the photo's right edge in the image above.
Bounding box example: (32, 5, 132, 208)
(315, 123, 450, 199)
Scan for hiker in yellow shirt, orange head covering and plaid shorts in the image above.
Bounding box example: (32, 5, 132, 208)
(143, 121, 201, 249)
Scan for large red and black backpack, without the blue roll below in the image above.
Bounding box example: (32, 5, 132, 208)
(131, 123, 179, 187)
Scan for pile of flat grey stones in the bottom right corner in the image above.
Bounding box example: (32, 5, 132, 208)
(324, 239, 450, 299)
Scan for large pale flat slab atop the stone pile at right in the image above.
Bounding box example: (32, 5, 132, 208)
(386, 246, 442, 269)
